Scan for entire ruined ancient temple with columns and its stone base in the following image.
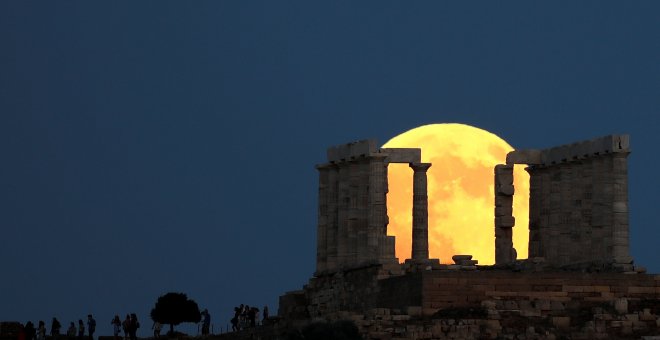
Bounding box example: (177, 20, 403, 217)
(269, 135, 660, 339)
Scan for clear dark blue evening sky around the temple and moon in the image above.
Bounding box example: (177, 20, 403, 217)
(0, 1, 660, 335)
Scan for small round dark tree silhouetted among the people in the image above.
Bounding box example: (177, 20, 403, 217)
(151, 293, 202, 333)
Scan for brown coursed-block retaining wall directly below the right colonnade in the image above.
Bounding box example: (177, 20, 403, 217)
(421, 270, 660, 315)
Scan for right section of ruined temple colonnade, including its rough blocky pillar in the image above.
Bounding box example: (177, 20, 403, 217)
(495, 135, 633, 271)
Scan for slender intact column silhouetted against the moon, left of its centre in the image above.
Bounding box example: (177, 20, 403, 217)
(410, 163, 431, 260)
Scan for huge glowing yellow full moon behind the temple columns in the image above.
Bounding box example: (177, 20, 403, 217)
(383, 124, 529, 264)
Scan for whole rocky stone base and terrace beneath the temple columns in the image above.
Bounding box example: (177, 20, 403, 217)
(280, 266, 660, 339)
